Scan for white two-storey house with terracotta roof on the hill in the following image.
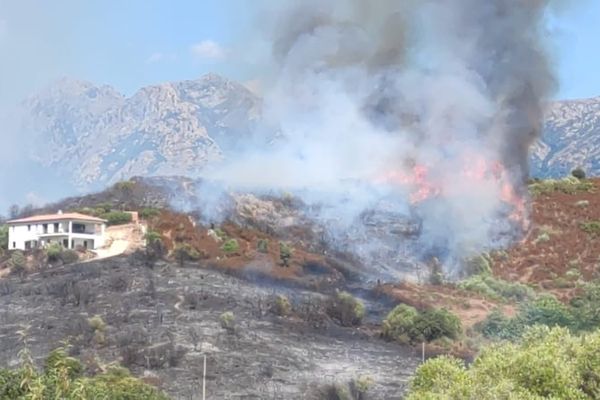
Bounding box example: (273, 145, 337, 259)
(7, 211, 106, 250)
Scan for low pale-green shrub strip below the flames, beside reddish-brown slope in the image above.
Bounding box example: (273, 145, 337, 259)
(458, 274, 535, 301)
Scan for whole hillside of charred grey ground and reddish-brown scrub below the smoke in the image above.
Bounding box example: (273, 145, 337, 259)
(0, 178, 600, 399)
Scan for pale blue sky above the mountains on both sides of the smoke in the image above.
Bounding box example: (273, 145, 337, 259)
(0, 0, 600, 105)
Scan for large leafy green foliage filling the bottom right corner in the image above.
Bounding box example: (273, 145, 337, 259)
(408, 326, 600, 400)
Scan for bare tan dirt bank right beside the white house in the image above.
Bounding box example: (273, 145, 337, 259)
(94, 223, 146, 260)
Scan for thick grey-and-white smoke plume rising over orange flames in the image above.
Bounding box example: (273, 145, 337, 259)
(199, 0, 554, 278)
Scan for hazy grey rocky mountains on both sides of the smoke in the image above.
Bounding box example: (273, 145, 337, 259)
(19, 74, 600, 189)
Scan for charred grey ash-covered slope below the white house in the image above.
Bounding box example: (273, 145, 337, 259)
(0, 256, 419, 399)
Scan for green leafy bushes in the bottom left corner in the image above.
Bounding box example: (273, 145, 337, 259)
(0, 348, 168, 400)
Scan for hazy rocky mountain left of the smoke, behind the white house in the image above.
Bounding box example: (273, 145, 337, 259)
(23, 74, 261, 188)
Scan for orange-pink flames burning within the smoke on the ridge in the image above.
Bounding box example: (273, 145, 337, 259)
(375, 156, 529, 230)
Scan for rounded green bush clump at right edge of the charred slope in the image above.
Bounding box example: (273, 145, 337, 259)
(382, 304, 462, 344)
